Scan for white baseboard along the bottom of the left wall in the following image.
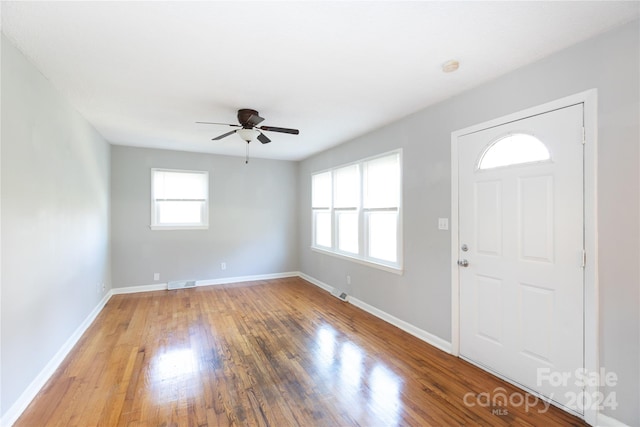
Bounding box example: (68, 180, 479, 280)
(0, 291, 112, 426)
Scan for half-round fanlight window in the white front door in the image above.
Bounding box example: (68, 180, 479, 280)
(478, 133, 551, 170)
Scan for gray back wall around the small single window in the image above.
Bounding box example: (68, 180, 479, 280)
(111, 145, 298, 287)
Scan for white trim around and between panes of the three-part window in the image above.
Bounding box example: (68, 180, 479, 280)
(310, 148, 404, 275)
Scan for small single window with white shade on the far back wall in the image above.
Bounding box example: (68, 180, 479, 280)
(151, 169, 209, 230)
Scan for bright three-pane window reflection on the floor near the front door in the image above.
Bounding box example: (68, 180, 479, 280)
(315, 325, 402, 426)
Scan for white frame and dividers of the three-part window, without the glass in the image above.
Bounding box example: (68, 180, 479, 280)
(310, 149, 404, 274)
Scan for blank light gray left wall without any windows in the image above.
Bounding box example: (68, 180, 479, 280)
(0, 36, 110, 414)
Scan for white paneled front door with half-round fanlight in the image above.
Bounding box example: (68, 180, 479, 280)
(458, 104, 584, 413)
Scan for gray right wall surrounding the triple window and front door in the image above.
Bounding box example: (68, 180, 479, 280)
(298, 21, 640, 425)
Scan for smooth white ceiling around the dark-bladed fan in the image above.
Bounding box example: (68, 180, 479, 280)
(1, 1, 640, 160)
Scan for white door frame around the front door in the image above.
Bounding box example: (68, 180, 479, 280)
(451, 89, 600, 425)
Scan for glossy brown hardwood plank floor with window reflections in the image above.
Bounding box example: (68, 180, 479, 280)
(15, 278, 585, 427)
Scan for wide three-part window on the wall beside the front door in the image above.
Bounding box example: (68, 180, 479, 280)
(311, 151, 402, 271)
